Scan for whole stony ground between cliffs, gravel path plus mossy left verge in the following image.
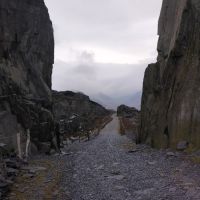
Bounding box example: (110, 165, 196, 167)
(6, 116, 200, 200)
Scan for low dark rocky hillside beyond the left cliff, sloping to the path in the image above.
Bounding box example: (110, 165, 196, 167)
(53, 91, 110, 135)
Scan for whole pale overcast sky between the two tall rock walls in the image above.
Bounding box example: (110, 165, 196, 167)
(45, 0, 162, 108)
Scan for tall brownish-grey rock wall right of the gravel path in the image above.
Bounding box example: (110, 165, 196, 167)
(139, 0, 200, 150)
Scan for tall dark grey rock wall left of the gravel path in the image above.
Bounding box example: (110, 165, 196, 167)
(0, 0, 54, 153)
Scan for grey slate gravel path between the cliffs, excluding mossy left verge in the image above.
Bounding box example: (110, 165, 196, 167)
(62, 117, 200, 200)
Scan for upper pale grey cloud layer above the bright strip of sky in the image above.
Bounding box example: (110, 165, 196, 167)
(46, 0, 161, 59)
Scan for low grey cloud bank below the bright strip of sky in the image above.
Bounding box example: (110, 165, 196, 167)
(53, 60, 147, 108)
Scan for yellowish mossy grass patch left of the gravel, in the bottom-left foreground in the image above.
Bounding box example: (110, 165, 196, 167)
(9, 160, 61, 200)
